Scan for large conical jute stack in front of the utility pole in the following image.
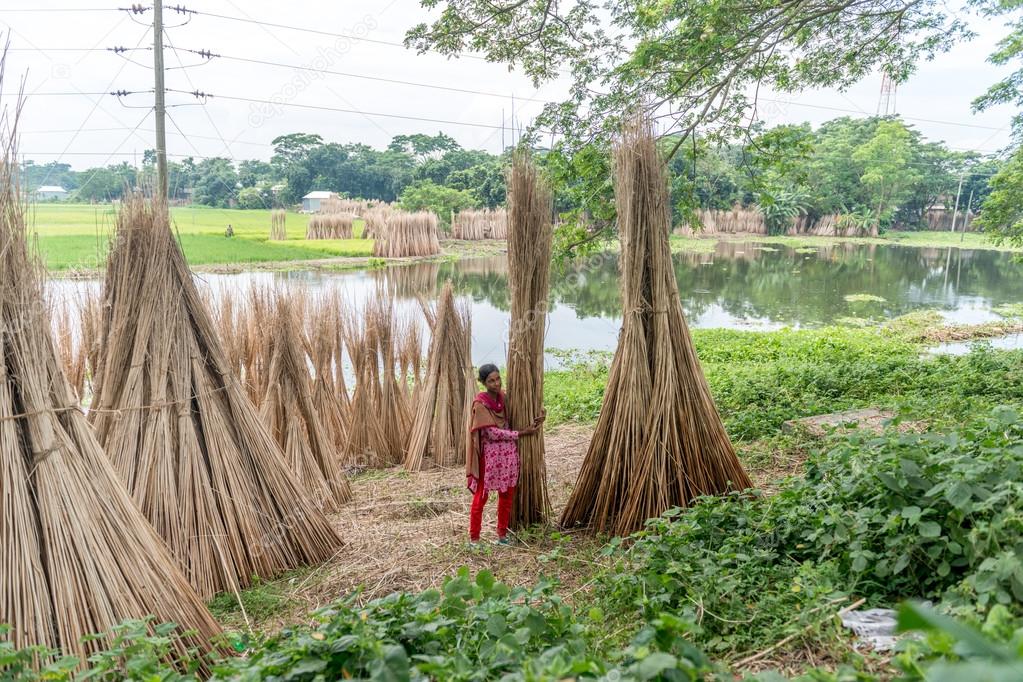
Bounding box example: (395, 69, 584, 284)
(93, 194, 342, 597)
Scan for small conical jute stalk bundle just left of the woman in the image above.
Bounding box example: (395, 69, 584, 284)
(404, 282, 473, 471)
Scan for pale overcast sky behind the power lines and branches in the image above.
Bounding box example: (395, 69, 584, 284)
(0, 0, 1014, 169)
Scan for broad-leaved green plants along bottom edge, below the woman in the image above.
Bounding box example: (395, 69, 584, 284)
(215, 569, 709, 681)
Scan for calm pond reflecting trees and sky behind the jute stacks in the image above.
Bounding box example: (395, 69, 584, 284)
(51, 241, 1023, 362)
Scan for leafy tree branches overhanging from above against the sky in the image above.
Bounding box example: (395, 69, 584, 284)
(405, 0, 967, 147)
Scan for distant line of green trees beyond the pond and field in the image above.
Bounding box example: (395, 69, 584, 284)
(25, 118, 1002, 235)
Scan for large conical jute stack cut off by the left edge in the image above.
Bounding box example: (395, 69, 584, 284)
(0, 78, 219, 661)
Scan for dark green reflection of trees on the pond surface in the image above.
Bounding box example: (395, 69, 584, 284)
(394, 241, 1023, 324)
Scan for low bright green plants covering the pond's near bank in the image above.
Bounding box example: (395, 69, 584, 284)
(544, 329, 1023, 442)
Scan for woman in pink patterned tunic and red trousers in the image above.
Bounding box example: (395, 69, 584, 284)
(465, 365, 544, 545)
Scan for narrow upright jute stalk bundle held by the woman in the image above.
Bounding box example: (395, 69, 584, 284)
(507, 153, 553, 529)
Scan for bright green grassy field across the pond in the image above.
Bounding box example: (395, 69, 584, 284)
(30, 203, 372, 271)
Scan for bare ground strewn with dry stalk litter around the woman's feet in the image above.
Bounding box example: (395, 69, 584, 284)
(221, 424, 803, 632)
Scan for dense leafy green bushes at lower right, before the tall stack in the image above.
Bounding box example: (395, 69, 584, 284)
(601, 408, 1023, 653)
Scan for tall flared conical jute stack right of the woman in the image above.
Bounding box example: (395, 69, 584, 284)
(562, 121, 752, 535)
